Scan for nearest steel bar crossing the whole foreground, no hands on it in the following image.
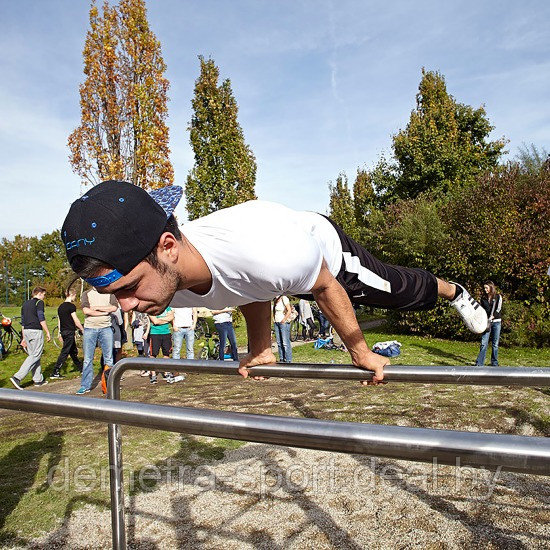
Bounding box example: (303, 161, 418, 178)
(0, 389, 550, 475)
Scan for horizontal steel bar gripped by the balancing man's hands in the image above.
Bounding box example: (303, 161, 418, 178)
(110, 357, 550, 387)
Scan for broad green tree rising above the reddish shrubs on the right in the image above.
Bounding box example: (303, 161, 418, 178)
(374, 69, 506, 202)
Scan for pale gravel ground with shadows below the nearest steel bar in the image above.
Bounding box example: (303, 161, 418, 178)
(13, 444, 550, 550)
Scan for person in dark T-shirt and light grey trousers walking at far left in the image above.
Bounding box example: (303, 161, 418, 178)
(10, 286, 50, 390)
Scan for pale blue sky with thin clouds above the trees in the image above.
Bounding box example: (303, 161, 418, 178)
(0, 0, 550, 237)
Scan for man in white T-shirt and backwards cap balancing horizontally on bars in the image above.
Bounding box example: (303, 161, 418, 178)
(61, 181, 487, 384)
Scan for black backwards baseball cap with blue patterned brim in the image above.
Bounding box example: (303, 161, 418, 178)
(61, 180, 183, 287)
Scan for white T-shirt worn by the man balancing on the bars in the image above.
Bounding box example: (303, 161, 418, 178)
(170, 201, 342, 309)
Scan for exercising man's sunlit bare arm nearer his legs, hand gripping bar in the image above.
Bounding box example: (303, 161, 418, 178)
(311, 262, 389, 383)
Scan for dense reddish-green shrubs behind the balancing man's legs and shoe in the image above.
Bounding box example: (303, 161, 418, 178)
(364, 165, 550, 346)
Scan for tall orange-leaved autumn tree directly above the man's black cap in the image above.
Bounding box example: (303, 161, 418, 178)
(68, 0, 174, 189)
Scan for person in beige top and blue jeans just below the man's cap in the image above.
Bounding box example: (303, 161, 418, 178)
(76, 288, 119, 395)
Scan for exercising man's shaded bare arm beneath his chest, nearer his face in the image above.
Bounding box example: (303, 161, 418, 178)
(239, 302, 275, 378)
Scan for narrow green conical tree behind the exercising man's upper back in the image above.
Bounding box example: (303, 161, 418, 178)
(185, 56, 256, 220)
